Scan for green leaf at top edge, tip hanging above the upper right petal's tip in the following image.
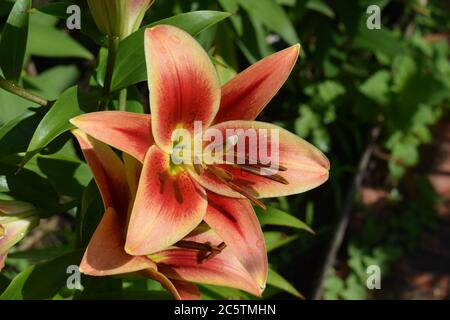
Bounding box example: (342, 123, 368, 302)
(238, 0, 300, 45)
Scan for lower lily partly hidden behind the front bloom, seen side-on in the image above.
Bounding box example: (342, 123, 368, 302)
(73, 129, 262, 299)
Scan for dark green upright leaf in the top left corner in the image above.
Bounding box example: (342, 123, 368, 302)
(0, 0, 31, 82)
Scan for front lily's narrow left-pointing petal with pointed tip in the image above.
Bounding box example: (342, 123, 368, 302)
(70, 111, 154, 162)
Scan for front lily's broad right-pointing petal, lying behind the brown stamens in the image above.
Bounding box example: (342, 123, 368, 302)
(190, 121, 330, 198)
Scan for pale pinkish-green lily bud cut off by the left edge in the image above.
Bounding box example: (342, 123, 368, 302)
(0, 200, 39, 271)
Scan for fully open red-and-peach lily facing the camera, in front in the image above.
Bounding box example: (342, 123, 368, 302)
(71, 25, 329, 288)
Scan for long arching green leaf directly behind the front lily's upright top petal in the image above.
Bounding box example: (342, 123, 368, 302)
(112, 11, 230, 91)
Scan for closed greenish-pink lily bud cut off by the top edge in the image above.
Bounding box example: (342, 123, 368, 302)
(88, 0, 155, 39)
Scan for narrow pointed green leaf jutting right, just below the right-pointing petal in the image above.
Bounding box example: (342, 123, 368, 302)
(255, 206, 314, 233)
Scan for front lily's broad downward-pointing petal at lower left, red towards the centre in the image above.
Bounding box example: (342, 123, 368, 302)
(125, 146, 207, 255)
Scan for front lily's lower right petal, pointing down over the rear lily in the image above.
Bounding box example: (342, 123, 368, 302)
(204, 192, 267, 288)
